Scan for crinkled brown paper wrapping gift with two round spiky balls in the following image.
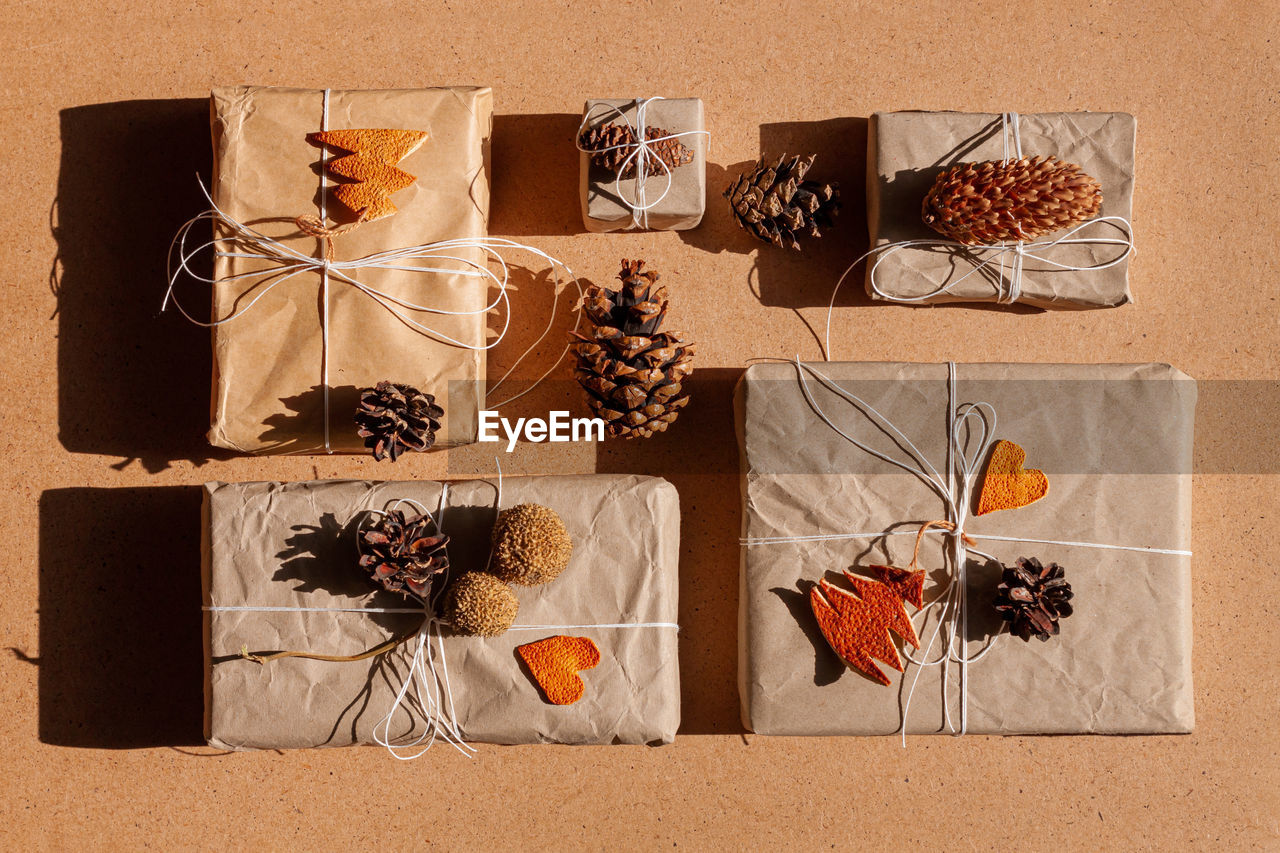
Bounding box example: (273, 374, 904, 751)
(204, 475, 680, 749)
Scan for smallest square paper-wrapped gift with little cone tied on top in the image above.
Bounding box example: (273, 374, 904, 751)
(577, 97, 708, 233)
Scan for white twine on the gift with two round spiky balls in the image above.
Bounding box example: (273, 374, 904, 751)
(205, 459, 680, 761)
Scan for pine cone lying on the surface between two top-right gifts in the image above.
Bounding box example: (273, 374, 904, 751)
(724, 154, 840, 250)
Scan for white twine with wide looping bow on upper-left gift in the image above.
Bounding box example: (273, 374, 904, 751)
(160, 90, 582, 453)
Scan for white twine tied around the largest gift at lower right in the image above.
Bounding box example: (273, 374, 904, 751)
(740, 356, 1192, 745)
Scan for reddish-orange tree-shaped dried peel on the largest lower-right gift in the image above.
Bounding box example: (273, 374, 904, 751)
(809, 566, 924, 685)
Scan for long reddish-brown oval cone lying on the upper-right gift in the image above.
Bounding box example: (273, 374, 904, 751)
(922, 155, 1102, 246)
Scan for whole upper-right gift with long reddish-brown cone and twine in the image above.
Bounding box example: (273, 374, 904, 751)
(867, 111, 1135, 309)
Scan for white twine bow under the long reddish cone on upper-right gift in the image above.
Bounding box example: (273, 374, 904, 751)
(827, 113, 1137, 317)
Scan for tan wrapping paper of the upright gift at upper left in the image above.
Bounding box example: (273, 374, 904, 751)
(209, 86, 493, 453)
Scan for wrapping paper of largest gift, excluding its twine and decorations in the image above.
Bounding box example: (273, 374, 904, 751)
(736, 362, 1196, 735)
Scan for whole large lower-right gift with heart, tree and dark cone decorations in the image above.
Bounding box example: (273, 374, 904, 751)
(736, 361, 1196, 736)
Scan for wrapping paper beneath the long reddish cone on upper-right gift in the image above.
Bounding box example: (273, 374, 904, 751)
(867, 111, 1137, 309)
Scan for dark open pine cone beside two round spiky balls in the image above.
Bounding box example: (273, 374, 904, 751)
(360, 510, 449, 598)
